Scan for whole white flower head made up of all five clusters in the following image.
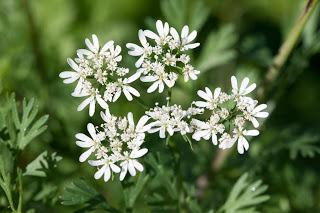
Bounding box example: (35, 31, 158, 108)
(60, 20, 268, 181)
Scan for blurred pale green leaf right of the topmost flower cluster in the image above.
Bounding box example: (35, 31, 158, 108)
(197, 25, 238, 72)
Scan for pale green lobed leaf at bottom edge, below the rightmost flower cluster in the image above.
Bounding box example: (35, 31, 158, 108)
(219, 173, 270, 213)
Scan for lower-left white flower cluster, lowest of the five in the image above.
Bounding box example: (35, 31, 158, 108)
(76, 112, 150, 181)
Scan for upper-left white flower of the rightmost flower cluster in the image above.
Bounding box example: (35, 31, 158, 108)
(195, 87, 221, 110)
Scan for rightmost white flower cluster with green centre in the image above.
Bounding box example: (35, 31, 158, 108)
(191, 76, 268, 154)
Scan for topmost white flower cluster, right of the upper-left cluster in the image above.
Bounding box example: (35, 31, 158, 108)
(127, 20, 200, 93)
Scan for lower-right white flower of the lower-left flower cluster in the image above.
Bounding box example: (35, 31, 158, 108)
(120, 148, 148, 181)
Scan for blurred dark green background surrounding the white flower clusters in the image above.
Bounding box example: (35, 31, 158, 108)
(0, 0, 320, 212)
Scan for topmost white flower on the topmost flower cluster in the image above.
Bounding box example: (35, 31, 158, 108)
(144, 20, 169, 44)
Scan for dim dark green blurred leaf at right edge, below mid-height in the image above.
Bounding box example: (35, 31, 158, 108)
(288, 133, 320, 159)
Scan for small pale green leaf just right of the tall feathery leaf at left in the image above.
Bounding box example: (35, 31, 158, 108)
(23, 151, 62, 177)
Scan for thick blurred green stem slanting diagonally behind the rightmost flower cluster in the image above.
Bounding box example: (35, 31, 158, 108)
(212, 0, 319, 172)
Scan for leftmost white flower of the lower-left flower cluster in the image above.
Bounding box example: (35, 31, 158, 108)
(76, 123, 101, 162)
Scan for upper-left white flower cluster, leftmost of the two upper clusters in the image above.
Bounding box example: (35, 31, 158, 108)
(59, 35, 140, 116)
